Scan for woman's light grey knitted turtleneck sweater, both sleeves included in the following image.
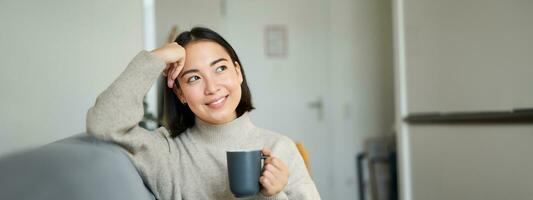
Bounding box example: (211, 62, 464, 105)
(87, 51, 320, 200)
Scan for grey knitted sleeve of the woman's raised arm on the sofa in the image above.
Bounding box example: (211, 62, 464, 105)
(86, 51, 181, 199)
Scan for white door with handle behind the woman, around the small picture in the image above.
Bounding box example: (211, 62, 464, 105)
(222, 0, 332, 199)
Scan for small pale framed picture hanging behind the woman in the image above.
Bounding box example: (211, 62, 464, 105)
(265, 25, 288, 58)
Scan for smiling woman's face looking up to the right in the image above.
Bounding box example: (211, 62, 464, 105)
(174, 41, 243, 124)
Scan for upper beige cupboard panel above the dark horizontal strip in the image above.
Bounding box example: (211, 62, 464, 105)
(405, 0, 533, 112)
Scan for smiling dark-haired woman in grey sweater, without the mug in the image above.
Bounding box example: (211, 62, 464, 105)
(87, 28, 320, 199)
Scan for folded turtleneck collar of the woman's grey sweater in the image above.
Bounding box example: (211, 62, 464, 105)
(192, 112, 255, 144)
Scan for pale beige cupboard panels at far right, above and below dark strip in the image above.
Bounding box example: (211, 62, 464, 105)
(395, 0, 533, 200)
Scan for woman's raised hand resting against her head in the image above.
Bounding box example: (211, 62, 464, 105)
(152, 42, 185, 88)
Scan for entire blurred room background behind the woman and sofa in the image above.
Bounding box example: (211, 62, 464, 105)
(0, 0, 533, 200)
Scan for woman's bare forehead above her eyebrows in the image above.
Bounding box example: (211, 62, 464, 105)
(185, 40, 231, 68)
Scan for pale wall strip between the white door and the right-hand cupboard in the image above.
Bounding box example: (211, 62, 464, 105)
(324, 0, 394, 199)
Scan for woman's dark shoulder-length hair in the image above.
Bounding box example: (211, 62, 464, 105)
(161, 27, 254, 138)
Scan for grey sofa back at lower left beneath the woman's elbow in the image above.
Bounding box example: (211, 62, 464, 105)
(0, 133, 155, 200)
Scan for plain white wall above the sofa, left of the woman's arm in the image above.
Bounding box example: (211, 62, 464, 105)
(0, 0, 143, 154)
